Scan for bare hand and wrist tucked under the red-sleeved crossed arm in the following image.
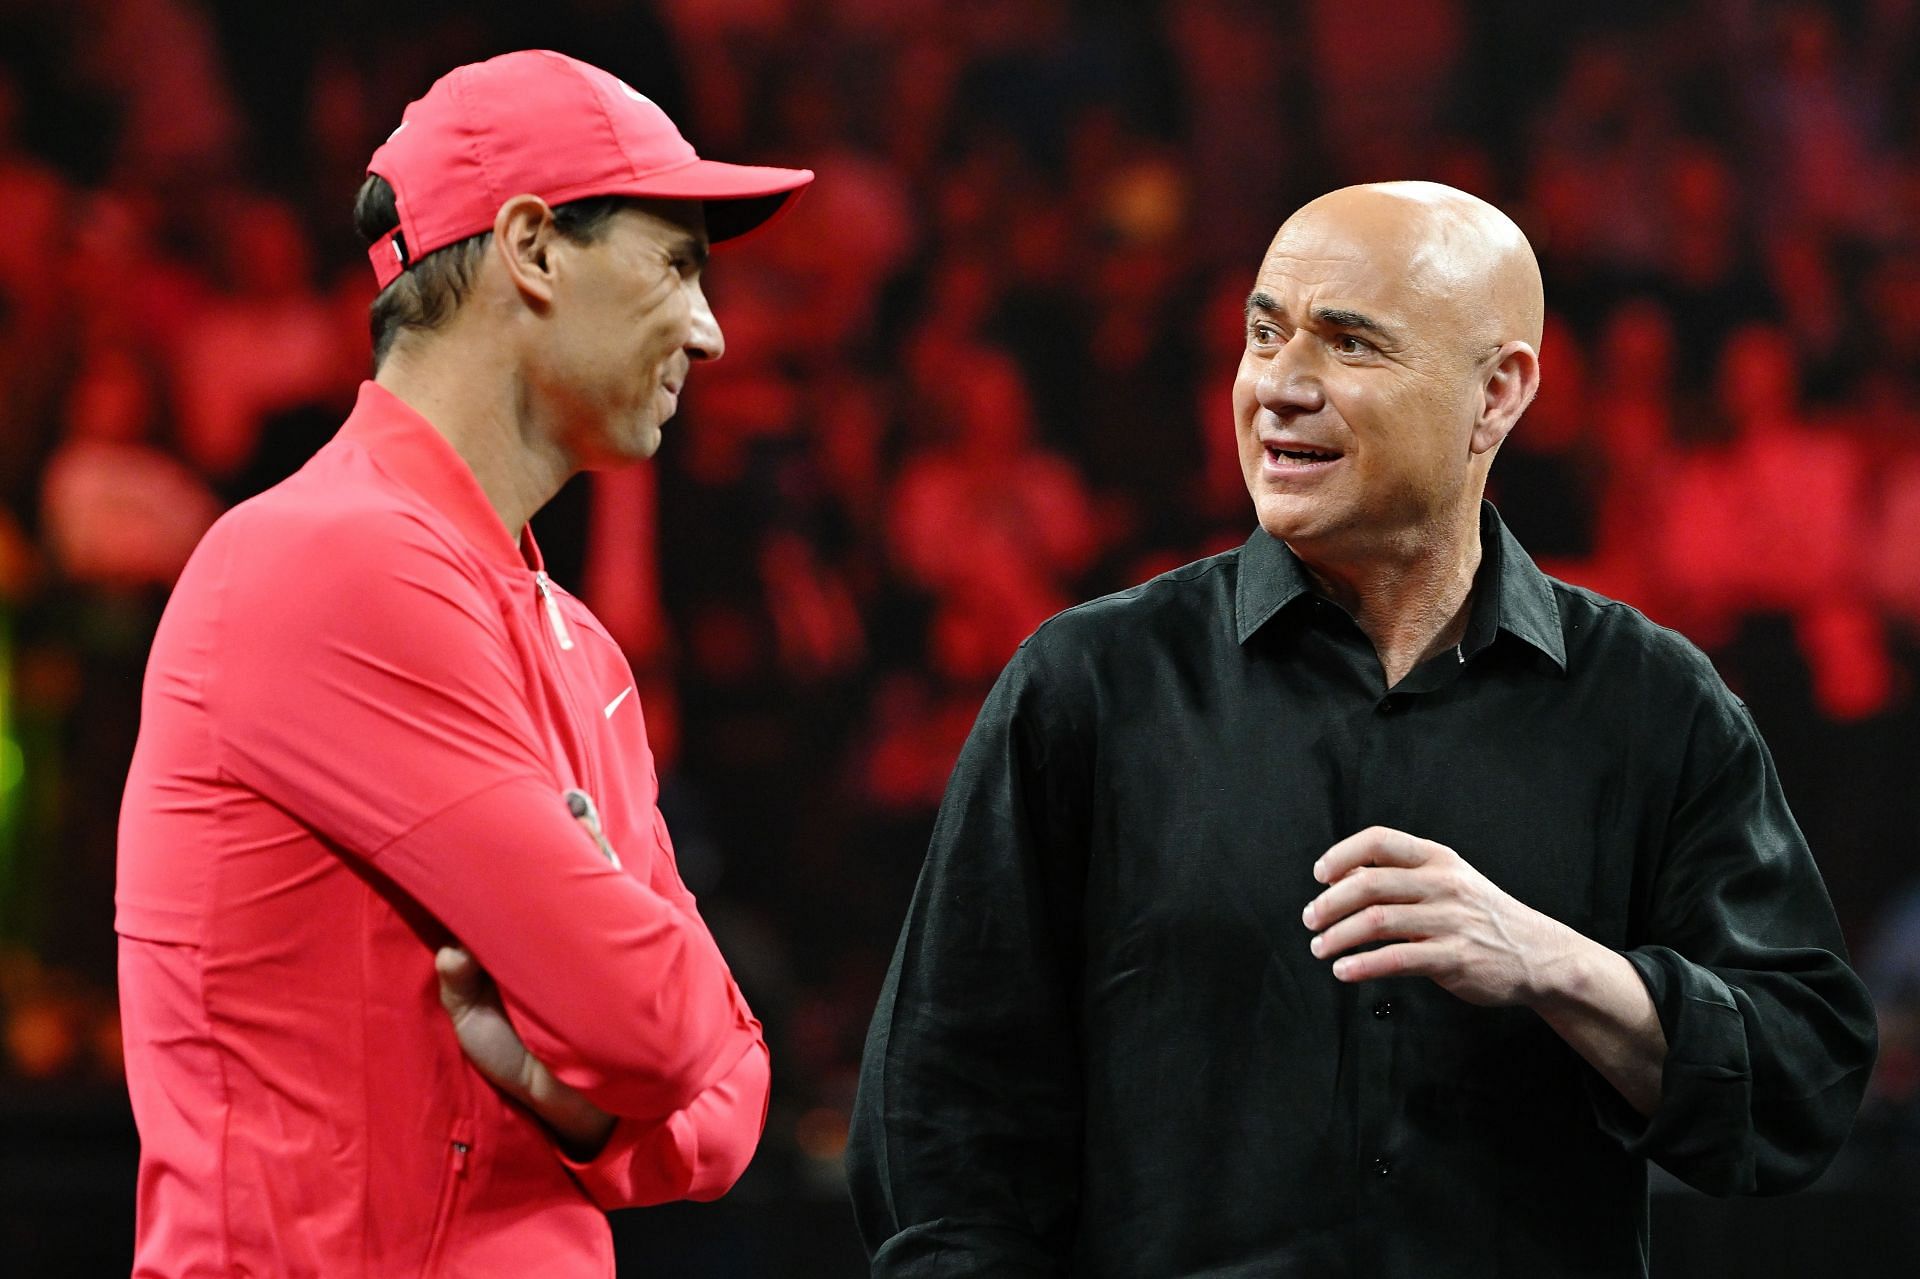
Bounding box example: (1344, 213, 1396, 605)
(434, 947, 614, 1160)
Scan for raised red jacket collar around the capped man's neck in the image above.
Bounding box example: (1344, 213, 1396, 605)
(338, 382, 545, 572)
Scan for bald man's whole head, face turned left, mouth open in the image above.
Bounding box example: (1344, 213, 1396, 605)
(1233, 182, 1546, 567)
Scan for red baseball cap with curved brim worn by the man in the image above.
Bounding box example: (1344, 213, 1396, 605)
(367, 50, 814, 288)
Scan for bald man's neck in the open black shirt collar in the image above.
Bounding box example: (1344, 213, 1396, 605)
(1294, 503, 1480, 688)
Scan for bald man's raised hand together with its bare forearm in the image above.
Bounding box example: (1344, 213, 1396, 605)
(1300, 826, 1667, 1116)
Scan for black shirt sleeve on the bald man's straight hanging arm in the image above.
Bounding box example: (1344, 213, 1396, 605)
(847, 641, 1085, 1279)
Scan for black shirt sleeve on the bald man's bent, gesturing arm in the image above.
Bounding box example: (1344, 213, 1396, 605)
(1599, 676, 1876, 1195)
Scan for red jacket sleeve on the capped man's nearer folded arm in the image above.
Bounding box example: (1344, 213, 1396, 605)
(207, 506, 758, 1120)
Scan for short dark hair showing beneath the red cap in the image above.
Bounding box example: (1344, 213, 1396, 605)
(353, 173, 634, 373)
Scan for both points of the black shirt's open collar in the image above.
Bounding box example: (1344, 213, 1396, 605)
(1233, 501, 1567, 670)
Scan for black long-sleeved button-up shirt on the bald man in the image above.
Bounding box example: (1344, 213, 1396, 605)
(849, 507, 1874, 1279)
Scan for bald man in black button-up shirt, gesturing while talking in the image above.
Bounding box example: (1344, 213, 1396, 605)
(849, 182, 1874, 1279)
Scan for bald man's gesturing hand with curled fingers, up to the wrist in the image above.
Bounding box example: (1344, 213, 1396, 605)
(1300, 826, 1584, 1006)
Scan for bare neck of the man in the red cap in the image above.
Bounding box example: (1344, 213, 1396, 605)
(374, 334, 572, 542)
